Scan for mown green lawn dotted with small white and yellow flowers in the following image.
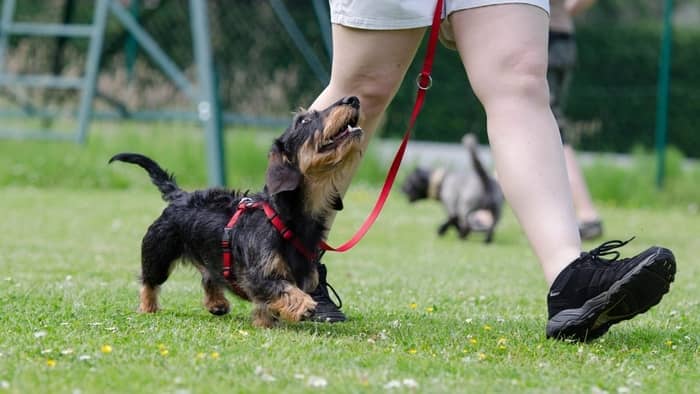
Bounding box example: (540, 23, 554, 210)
(0, 185, 700, 394)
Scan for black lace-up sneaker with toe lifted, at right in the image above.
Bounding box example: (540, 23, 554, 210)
(547, 239, 676, 341)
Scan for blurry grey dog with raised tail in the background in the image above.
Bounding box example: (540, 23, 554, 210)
(401, 134, 504, 243)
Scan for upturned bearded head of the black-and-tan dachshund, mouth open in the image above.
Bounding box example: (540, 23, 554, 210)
(266, 97, 364, 215)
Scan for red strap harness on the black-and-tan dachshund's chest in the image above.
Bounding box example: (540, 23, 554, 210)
(221, 197, 318, 298)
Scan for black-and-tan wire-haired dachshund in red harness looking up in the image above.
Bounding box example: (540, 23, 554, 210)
(109, 97, 364, 327)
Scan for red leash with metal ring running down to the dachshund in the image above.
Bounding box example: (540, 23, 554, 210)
(321, 0, 443, 252)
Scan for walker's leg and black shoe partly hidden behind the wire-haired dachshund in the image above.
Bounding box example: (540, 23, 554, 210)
(311, 24, 425, 322)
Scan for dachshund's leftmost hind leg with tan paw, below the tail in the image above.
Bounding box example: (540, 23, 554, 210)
(138, 216, 183, 313)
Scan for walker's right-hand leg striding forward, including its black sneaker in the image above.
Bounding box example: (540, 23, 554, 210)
(451, 4, 676, 341)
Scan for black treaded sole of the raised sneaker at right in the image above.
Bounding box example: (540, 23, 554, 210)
(546, 247, 676, 342)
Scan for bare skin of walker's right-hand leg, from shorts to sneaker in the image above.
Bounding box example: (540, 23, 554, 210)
(450, 4, 581, 284)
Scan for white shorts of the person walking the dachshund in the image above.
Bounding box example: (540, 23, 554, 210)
(330, 0, 549, 49)
